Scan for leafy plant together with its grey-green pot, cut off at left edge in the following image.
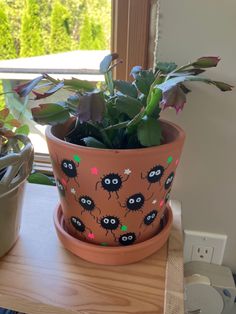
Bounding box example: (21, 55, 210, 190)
(0, 108, 33, 257)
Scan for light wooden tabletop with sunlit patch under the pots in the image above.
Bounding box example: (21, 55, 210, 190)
(0, 184, 184, 314)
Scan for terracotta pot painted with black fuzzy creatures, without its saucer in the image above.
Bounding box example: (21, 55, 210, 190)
(46, 121, 185, 246)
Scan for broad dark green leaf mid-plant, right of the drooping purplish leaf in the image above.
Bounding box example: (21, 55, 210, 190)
(115, 96, 143, 119)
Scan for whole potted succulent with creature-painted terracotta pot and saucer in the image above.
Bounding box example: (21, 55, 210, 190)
(15, 54, 231, 264)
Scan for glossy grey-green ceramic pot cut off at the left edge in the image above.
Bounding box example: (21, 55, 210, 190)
(0, 135, 34, 257)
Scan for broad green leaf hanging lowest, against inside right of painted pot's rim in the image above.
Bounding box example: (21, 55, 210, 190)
(137, 117, 161, 147)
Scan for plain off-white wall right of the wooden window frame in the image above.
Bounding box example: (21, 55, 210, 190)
(157, 0, 236, 271)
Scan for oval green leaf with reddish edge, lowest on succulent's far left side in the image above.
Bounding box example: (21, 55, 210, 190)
(31, 103, 70, 125)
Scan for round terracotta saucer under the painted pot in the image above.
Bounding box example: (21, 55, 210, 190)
(54, 205, 173, 265)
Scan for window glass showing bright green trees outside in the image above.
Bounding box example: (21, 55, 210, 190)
(0, 0, 111, 153)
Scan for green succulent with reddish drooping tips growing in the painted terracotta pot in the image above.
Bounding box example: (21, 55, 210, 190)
(14, 53, 232, 149)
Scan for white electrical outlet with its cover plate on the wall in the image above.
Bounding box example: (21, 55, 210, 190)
(184, 230, 227, 265)
